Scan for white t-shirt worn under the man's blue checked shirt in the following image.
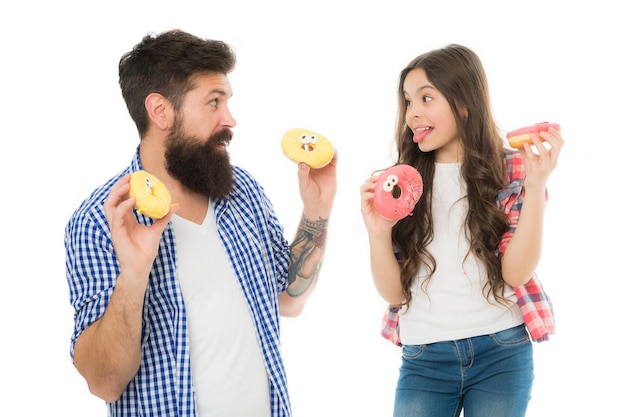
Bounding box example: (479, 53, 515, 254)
(172, 204, 270, 417)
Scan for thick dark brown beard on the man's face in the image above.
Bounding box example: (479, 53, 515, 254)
(165, 120, 233, 198)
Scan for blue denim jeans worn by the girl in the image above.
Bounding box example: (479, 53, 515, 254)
(393, 324, 533, 417)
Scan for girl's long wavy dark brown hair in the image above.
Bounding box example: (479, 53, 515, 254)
(392, 44, 508, 306)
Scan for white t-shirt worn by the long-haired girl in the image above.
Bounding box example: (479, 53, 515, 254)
(400, 163, 523, 345)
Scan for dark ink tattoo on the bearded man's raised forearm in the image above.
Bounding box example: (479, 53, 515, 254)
(287, 216, 328, 297)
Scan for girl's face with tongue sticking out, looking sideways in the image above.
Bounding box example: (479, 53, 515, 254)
(403, 68, 463, 163)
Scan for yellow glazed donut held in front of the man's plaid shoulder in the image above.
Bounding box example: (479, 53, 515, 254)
(130, 171, 172, 219)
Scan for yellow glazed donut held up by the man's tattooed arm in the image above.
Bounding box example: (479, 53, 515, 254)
(281, 128, 335, 168)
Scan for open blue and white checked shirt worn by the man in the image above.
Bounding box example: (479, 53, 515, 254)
(65, 150, 291, 417)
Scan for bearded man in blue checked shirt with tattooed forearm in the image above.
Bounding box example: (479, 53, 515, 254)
(65, 30, 337, 417)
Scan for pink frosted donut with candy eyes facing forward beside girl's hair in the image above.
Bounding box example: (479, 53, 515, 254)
(374, 164, 424, 220)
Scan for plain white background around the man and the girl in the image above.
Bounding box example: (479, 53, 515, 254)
(0, 0, 626, 417)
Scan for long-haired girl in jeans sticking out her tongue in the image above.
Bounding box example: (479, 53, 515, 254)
(361, 45, 563, 417)
